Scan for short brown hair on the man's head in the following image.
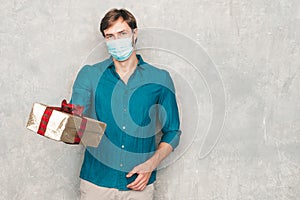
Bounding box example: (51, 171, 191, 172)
(100, 8, 137, 37)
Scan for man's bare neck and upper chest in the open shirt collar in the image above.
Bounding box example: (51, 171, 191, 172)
(113, 51, 138, 83)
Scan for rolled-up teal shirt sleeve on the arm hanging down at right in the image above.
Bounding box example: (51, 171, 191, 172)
(158, 71, 181, 150)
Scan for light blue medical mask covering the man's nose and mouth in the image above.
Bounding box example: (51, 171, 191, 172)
(106, 37, 133, 61)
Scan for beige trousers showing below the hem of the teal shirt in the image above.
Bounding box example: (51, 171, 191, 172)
(80, 179, 154, 200)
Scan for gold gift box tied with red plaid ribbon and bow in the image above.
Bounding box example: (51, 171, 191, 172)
(26, 100, 106, 147)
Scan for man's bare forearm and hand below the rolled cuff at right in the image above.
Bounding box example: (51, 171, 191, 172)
(126, 142, 173, 191)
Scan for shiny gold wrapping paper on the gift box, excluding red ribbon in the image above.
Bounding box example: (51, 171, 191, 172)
(26, 103, 106, 147)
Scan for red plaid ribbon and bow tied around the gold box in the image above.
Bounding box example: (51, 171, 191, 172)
(37, 99, 87, 144)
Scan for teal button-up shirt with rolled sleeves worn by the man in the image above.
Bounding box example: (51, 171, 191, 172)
(71, 55, 181, 190)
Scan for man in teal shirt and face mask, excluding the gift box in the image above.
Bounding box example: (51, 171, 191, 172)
(71, 9, 181, 200)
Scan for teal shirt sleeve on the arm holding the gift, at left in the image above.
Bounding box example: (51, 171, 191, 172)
(70, 65, 92, 116)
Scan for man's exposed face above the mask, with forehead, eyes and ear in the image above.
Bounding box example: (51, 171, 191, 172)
(104, 17, 137, 41)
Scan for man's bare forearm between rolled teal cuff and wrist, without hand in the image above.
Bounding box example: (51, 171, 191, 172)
(146, 142, 173, 170)
